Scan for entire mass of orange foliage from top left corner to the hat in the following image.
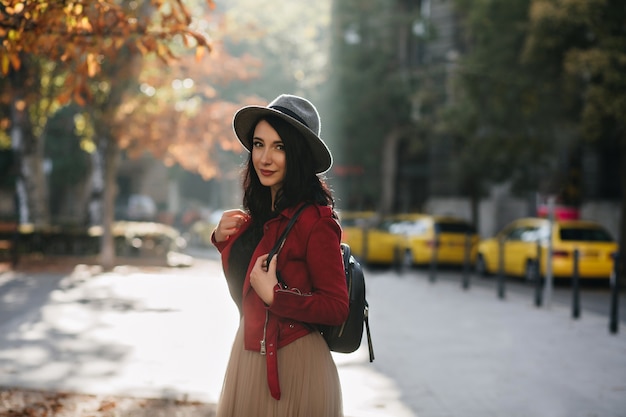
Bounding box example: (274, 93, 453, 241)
(0, 0, 260, 179)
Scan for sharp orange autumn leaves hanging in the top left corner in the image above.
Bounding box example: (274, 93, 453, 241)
(0, 0, 214, 86)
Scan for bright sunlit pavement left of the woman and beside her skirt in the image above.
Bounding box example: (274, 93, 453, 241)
(0, 260, 413, 417)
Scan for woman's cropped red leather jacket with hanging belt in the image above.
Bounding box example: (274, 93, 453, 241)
(212, 205, 348, 399)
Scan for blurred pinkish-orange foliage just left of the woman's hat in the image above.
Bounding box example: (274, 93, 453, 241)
(115, 48, 262, 179)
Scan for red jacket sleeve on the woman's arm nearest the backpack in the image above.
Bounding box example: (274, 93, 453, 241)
(269, 216, 348, 325)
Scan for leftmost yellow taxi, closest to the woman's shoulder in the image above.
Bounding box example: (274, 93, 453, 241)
(340, 211, 403, 265)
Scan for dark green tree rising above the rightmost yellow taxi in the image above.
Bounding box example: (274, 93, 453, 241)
(440, 0, 573, 228)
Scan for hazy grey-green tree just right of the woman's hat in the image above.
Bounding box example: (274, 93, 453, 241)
(325, 0, 415, 214)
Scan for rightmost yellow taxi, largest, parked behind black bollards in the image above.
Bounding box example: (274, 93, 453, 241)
(475, 217, 617, 279)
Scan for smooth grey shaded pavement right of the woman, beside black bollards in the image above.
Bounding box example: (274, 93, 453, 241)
(368, 271, 626, 417)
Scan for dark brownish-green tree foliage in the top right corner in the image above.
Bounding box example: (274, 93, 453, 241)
(524, 0, 626, 280)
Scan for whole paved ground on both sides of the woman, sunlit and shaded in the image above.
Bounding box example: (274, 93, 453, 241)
(0, 254, 626, 417)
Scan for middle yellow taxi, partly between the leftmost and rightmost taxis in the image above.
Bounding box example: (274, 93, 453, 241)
(394, 215, 479, 266)
